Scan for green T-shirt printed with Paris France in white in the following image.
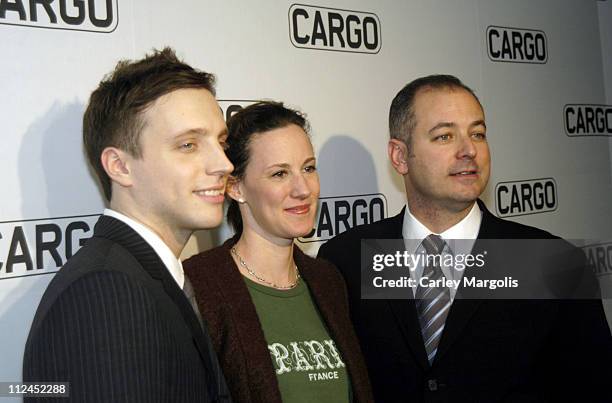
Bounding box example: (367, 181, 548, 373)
(244, 277, 350, 403)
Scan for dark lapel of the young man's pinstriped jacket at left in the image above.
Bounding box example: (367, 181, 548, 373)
(94, 215, 212, 373)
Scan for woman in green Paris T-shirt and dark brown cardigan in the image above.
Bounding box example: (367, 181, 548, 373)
(184, 102, 372, 403)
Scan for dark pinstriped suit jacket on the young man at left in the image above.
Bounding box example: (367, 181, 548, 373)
(23, 216, 231, 403)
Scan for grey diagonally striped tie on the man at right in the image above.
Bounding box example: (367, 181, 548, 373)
(415, 234, 451, 364)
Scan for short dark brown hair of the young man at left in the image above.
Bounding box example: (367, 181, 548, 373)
(83, 47, 215, 200)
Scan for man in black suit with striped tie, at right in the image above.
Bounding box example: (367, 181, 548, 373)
(319, 75, 612, 403)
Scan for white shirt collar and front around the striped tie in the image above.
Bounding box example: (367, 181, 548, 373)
(402, 203, 482, 300)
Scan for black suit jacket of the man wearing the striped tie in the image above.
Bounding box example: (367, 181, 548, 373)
(319, 201, 612, 403)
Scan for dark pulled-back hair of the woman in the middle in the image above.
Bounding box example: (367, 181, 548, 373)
(225, 101, 310, 234)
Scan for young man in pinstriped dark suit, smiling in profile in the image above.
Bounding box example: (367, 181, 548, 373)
(23, 48, 233, 403)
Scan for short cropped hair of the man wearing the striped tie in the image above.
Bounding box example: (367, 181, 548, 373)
(389, 74, 482, 149)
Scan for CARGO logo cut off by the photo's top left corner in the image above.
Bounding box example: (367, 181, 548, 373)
(0, 0, 119, 33)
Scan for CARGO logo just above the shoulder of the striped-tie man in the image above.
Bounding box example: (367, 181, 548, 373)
(495, 178, 558, 217)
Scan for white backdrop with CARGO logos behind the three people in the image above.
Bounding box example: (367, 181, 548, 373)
(0, 0, 612, 392)
